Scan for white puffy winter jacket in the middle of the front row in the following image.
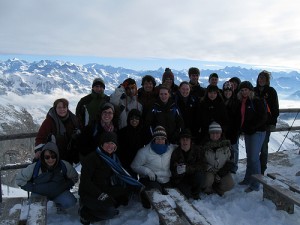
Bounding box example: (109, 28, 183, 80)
(131, 143, 176, 184)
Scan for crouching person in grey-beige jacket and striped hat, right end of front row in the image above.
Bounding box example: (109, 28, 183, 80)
(201, 122, 234, 196)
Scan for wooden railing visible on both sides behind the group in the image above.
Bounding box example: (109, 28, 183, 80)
(0, 108, 300, 202)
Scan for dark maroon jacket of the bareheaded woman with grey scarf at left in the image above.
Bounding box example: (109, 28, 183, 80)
(35, 107, 80, 164)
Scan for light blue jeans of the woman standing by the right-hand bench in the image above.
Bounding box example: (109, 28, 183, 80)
(244, 131, 266, 191)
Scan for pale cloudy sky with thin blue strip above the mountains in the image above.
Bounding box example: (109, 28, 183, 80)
(0, 0, 300, 71)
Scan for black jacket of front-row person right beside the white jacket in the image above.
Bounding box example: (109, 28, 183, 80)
(170, 145, 203, 184)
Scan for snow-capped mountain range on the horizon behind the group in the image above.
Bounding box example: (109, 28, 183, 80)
(0, 58, 300, 100)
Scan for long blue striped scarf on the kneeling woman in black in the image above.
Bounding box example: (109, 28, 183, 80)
(96, 147, 144, 188)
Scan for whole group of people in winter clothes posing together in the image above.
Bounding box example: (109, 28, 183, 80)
(17, 67, 279, 224)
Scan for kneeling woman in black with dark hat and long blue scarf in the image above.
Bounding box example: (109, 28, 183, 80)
(79, 132, 143, 224)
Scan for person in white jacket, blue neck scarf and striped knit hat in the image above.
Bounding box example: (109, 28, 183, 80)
(131, 126, 177, 208)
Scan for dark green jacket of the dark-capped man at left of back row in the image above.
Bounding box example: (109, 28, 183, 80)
(76, 91, 109, 127)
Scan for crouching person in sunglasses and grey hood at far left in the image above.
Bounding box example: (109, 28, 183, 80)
(16, 135, 78, 209)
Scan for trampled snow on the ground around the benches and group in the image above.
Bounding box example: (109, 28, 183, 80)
(3, 146, 300, 225)
